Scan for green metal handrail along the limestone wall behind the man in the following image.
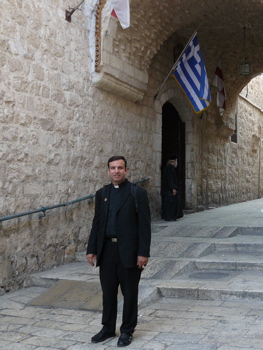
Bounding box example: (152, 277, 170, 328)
(0, 177, 150, 222)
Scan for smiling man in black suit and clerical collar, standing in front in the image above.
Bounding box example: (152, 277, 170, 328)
(87, 156, 151, 347)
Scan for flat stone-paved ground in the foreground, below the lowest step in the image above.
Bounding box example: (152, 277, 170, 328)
(0, 287, 263, 350)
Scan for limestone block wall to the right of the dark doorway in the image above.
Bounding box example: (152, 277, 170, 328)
(198, 96, 263, 208)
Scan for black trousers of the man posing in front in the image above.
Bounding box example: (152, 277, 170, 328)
(100, 241, 141, 333)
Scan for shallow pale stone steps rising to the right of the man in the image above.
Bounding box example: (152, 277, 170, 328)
(144, 226, 263, 300)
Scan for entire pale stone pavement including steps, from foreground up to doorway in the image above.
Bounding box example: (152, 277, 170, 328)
(0, 199, 263, 350)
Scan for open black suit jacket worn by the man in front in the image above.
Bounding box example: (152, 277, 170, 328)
(87, 180, 151, 268)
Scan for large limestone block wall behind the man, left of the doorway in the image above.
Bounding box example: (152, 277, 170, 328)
(0, 0, 157, 292)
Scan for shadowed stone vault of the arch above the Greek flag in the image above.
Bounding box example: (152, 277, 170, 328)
(94, 0, 263, 108)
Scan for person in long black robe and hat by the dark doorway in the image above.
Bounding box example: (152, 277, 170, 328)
(161, 154, 184, 221)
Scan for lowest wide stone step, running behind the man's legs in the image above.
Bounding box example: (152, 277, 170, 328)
(25, 260, 263, 307)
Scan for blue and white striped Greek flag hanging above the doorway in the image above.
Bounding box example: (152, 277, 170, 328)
(173, 33, 211, 113)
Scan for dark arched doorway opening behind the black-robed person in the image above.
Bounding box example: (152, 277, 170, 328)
(161, 102, 185, 208)
